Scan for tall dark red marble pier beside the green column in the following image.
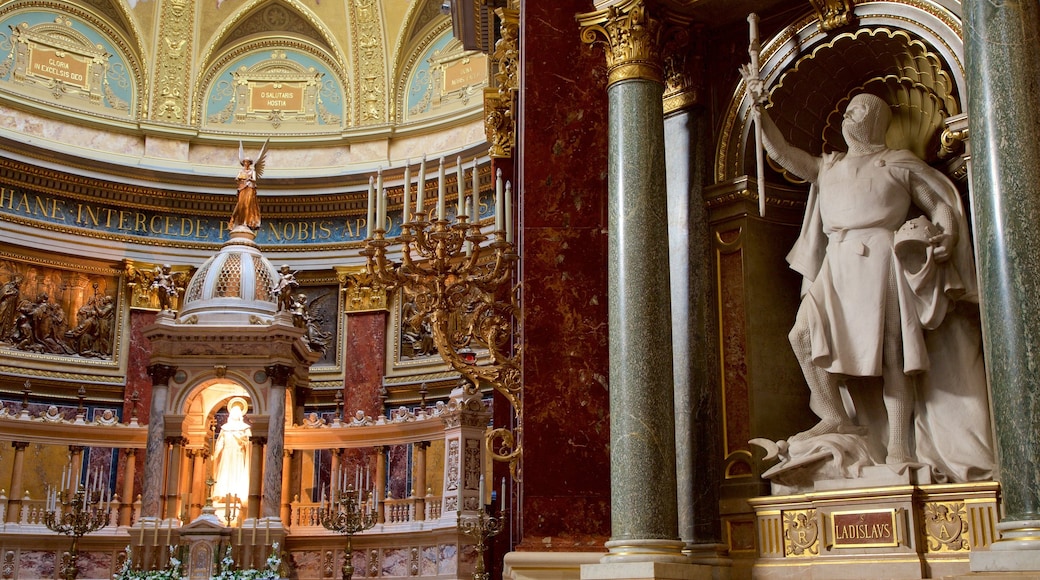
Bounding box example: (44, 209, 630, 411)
(515, 0, 610, 551)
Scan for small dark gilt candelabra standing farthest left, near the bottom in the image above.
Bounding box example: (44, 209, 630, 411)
(44, 485, 108, 580)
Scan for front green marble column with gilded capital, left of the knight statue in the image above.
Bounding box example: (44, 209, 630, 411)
(578, 1, 686, 563)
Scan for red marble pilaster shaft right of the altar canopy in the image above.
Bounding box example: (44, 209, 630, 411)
(343, 311, 387, 420)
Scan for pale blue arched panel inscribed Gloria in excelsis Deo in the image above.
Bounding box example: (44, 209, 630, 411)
(0, 2, 142, 121)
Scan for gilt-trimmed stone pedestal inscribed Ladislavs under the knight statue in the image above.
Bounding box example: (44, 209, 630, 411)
(749, 482, 997, 580)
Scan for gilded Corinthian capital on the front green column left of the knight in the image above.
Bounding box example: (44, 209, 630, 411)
(577, 0, 664, 86)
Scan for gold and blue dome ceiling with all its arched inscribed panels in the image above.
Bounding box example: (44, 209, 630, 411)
(0, 0, 488, 179)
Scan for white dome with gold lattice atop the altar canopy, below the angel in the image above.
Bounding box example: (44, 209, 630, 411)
(178, 228, 278, 324)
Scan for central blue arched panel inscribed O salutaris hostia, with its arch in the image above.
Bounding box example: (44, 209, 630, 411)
(192, 0, 350, 133)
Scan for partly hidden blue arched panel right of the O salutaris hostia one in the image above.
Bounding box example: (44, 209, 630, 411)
(397, 26, 488, 123)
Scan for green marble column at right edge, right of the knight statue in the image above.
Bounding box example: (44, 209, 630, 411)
(963, 0, 1040, 572)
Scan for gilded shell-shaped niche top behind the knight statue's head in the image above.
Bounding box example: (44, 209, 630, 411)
(716, 2, 964, 182)
